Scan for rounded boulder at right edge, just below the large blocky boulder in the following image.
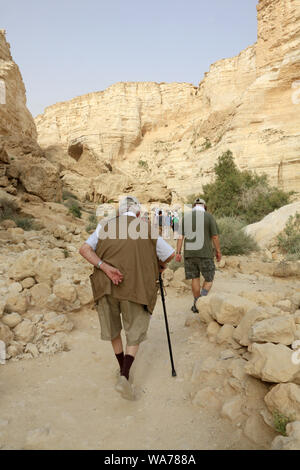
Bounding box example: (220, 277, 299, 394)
(265, 383, 300, 421)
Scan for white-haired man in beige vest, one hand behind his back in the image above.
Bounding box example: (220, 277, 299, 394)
(79, 197, 175, 400)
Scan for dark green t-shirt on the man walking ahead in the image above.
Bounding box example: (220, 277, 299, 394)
(182, 210, 219, 258)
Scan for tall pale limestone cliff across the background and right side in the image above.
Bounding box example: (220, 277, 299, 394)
(36, 0, 300, 201)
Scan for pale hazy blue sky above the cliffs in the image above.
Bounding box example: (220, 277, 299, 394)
(0, 0, 258, 116)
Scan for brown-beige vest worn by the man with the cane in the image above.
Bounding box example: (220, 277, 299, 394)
(90, 216, 159, 313)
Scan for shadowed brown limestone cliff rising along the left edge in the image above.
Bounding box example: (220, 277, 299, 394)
(0, 30, 61, 201)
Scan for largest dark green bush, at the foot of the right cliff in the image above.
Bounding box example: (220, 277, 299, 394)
(195, 150, 292, 224)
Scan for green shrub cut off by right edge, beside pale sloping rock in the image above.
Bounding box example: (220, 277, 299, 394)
(277, 212, 300, 259)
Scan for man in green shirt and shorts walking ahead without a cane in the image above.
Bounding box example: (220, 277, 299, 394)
(176, 198, 222, 313)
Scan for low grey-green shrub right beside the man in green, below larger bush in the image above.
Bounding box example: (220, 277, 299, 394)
(217, 217, 258, 255)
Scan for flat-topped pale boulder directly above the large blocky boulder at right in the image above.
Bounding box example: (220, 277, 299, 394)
(249, 316, 296, 345)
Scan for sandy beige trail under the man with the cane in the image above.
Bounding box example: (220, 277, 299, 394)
(0, 281, 272, 450)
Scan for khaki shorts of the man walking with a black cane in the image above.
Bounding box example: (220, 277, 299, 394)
(96, 295, 151, 346)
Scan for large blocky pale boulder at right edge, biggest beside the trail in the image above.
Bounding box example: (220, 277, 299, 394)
(245, 343, 300, 383)
